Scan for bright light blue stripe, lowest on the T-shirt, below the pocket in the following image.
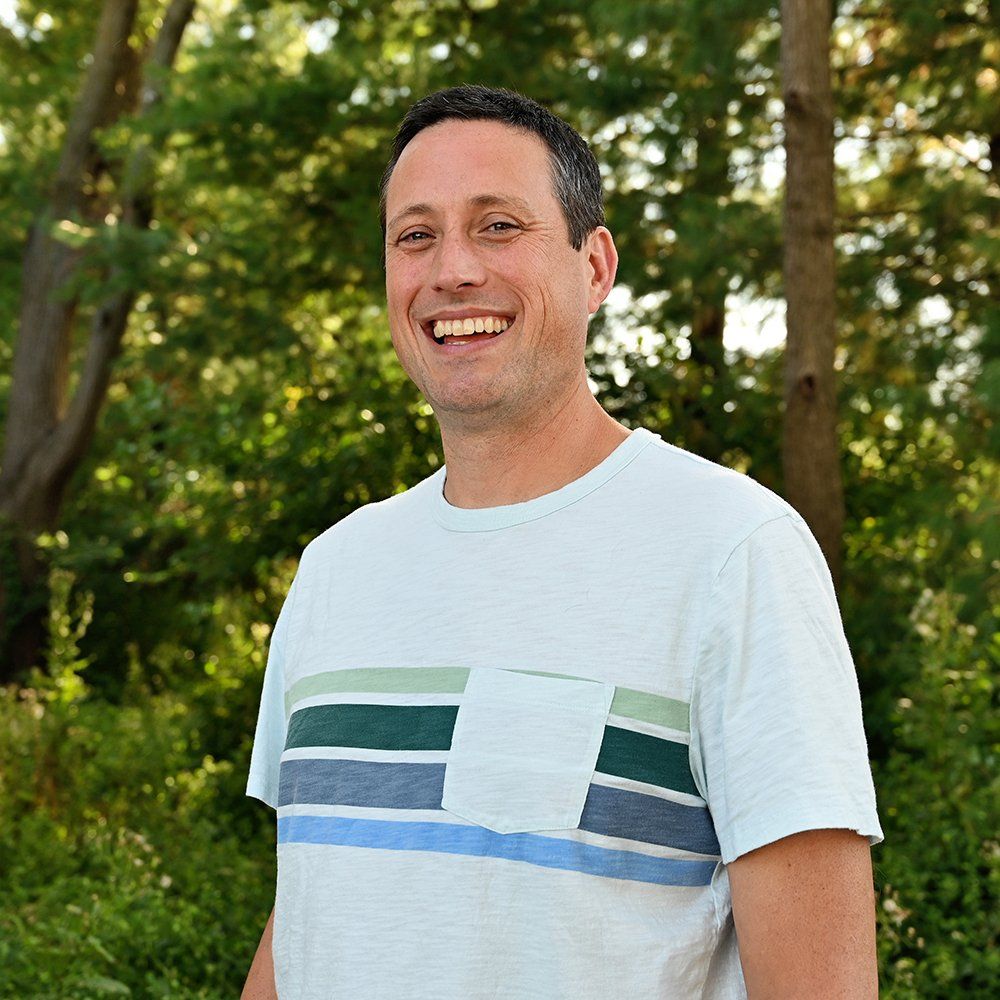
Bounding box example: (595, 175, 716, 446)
(278, 816, 716, 886)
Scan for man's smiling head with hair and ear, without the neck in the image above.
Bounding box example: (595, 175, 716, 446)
(381, 87, 617, 431)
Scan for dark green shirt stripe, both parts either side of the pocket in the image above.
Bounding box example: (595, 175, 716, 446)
(285, 705, 698, 795)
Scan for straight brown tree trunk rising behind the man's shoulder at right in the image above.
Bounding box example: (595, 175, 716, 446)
(781, 0, 844, 583)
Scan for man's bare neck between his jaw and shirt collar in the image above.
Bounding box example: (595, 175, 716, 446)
(441, 387, 629, 508)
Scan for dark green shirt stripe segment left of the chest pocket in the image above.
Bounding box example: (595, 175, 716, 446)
(285, 705, 458, 750)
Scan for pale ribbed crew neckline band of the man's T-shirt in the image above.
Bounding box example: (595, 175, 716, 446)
(431, 427, 660, 531)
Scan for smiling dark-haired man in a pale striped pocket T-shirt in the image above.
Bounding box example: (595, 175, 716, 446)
(244, 87, 881, 1000)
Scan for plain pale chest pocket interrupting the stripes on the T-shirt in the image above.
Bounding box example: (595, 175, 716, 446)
(441, 668, 615, 833)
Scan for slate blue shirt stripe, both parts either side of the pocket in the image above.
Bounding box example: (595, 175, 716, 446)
(278, 758, 719, 855)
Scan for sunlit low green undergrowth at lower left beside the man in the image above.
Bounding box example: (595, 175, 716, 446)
(0, 576, 274, 1000)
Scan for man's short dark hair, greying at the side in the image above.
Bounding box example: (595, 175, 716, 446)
(379, 84, 605, 260)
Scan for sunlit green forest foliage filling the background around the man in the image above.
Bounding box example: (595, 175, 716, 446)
(0, 0, 1000, 1000)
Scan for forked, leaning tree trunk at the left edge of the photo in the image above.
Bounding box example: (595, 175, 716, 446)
(0, 0, 195, 683)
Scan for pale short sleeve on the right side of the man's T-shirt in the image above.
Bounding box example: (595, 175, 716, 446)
(691, 514, 882, 864)
